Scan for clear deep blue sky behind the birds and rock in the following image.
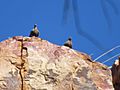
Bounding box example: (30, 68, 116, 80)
(0, 0, 120, 65)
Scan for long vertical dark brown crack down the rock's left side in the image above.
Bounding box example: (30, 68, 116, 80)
(11, 37, 28, 90)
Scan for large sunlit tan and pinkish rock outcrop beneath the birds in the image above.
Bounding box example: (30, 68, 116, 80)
(0, 36, 114, 90)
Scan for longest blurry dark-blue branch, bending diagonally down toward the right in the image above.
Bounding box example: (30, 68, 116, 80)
(72, 0, 105, 50)
